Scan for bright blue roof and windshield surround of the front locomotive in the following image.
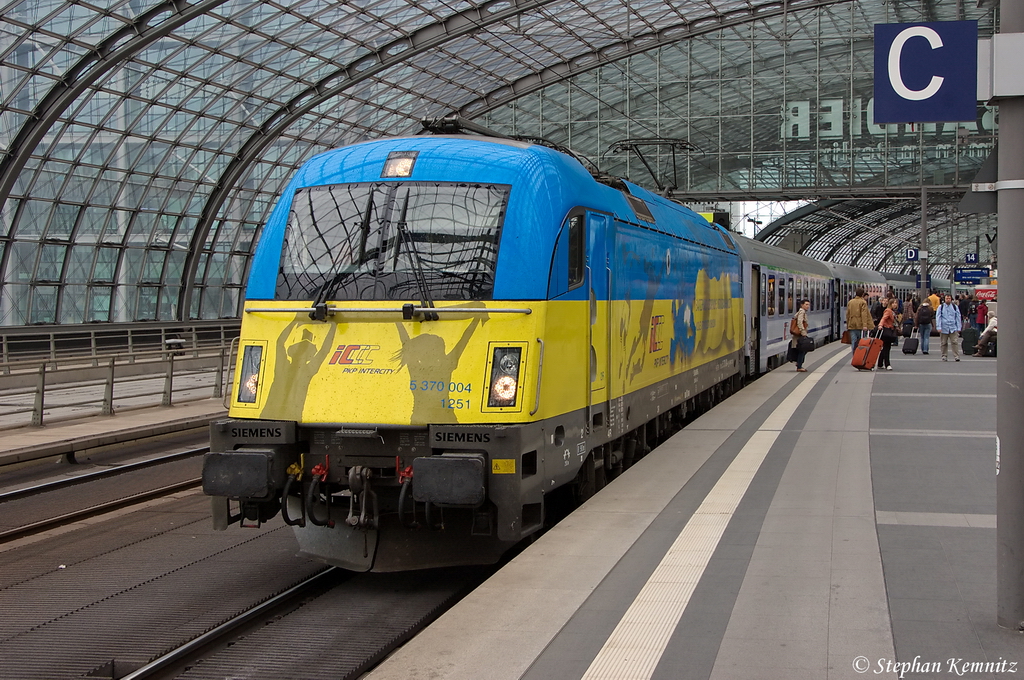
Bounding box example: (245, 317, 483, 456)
(246, 136, 724, 300)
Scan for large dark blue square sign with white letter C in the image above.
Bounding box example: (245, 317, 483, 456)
(873, 22, 978, 124)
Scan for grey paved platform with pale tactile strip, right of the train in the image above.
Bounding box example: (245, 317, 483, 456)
(367, 343, 1024, 680)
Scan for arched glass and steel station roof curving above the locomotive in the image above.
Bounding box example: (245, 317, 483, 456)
(0, 0, 992, 326)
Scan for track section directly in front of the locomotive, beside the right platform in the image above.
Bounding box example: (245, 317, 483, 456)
(117, 567, 494, 680)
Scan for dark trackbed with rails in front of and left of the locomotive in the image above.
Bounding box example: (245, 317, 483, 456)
(0, 440, 494, 680)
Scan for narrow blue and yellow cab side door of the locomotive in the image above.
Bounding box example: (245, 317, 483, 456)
(587, 213, 611, 429)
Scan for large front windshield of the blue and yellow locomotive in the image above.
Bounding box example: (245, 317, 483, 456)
(276, 182, 509, 300)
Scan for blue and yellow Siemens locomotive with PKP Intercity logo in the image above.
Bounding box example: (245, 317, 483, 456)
(203, 130, 790, 571)
